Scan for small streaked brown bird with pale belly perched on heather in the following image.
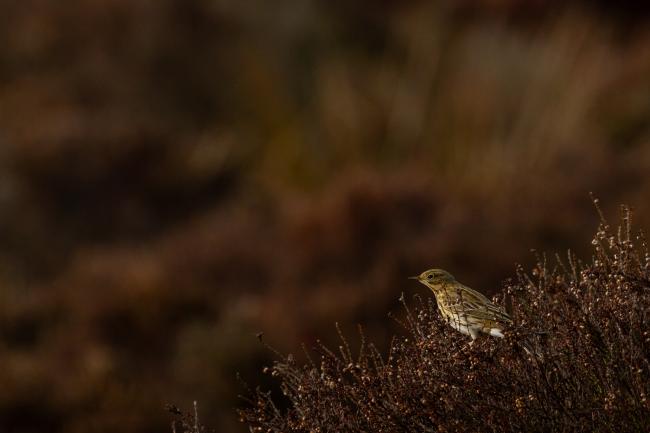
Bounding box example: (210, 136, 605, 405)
(409, 269, 512, 345)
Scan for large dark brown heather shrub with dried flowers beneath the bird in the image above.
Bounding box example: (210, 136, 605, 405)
(239, 209, 650, 432)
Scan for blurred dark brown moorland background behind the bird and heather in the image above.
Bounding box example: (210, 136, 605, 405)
(0, 0, 650, 433)
